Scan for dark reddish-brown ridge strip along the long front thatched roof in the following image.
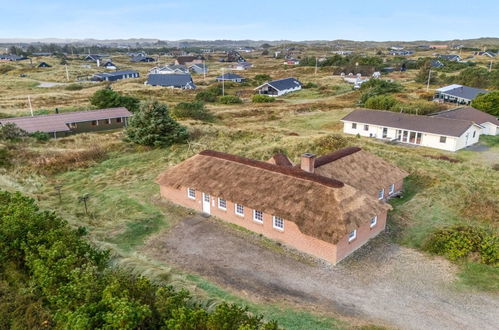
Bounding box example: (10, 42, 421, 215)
(199, 150, 345, 188)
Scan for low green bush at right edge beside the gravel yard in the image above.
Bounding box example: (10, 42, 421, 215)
(423, 226, 499, 265)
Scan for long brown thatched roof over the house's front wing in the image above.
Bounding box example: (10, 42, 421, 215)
(157, 150, 390, 244)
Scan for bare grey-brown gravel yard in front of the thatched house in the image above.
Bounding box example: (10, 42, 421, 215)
(144, 218, 499, 329)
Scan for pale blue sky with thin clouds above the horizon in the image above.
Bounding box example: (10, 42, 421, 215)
(0, 0, 499, 41)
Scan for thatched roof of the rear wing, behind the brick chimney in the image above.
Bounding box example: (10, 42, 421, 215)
(315, 147, 408, 196)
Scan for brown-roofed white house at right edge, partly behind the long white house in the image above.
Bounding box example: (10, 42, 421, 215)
(432, 107, 499, 135)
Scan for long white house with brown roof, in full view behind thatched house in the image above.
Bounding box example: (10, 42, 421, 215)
(341, 109, 482, 151)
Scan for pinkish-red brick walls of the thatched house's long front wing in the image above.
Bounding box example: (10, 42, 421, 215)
(160, 186, 386, 264)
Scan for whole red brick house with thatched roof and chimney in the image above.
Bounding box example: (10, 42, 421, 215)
(157, 148, 407, 264)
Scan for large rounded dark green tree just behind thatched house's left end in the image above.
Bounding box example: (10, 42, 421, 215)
(125, 101, 188, 147)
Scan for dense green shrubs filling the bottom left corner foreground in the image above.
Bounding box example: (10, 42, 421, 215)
(0, 191, 278, 330)
